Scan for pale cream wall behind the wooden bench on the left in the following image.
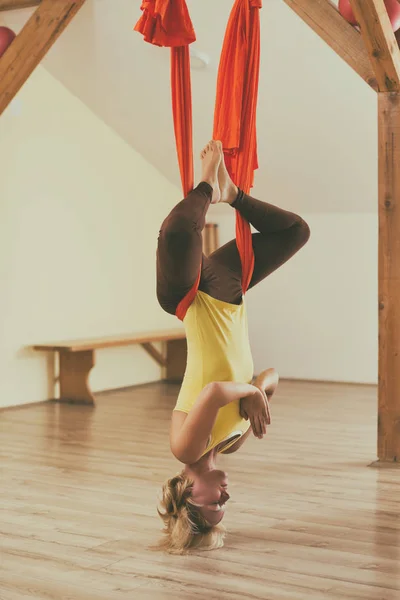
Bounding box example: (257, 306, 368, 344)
(0, 68, 180, 406)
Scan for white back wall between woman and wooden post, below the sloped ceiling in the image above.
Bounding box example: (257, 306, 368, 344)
(210, 206, 378, 383)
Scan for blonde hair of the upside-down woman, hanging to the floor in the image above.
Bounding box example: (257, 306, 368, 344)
(154, 472, 226, 554)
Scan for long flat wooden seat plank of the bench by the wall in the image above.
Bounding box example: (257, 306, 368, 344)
(32, 328, 186, 352)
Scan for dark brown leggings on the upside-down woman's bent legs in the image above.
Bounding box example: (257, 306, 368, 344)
(157, 182, 310, 314)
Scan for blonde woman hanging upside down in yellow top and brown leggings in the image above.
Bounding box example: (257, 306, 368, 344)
(157, 141, 310, 554)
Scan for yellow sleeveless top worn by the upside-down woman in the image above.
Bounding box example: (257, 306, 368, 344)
(175, 291, 253, 456)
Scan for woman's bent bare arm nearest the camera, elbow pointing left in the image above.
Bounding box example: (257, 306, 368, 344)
(171, 381, 259, 464)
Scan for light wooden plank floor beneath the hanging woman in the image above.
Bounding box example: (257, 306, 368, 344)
(0, 382, 400, 600)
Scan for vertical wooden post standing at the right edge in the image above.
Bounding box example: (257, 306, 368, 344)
(378, 92, 400, 462)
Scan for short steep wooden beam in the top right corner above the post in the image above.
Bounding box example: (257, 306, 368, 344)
(350, 0, 400, 92)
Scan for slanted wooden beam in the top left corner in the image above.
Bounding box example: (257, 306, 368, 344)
(0, 0, 85, 115)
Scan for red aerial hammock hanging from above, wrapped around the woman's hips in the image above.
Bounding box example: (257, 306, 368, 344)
(135, 0, 262, 320)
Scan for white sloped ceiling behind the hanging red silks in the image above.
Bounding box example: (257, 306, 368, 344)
(5, 0, 377, 213)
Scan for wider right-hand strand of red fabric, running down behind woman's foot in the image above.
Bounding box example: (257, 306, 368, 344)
(213, 0, 262, 292)
